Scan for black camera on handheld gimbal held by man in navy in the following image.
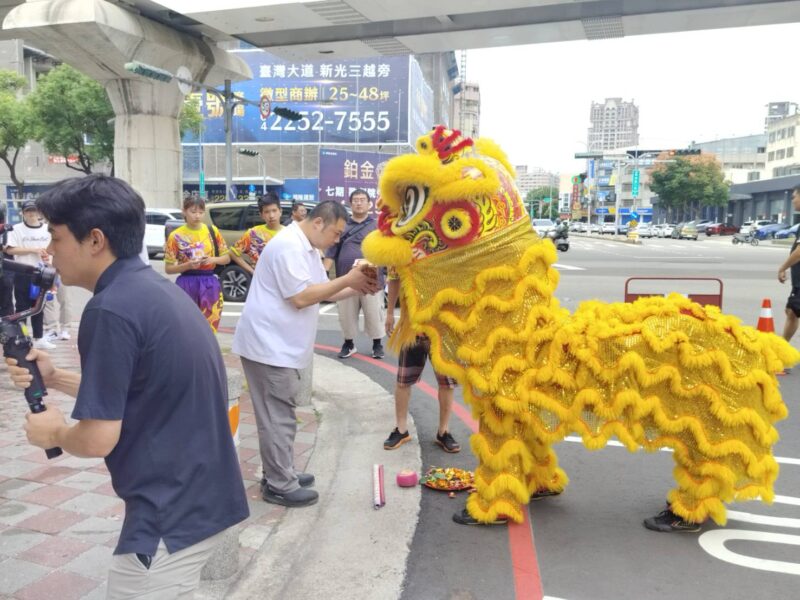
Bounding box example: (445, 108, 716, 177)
(0, 258, 61, 458)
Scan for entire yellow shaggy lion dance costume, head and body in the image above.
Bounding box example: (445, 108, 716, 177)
(363, 126, 800, 525)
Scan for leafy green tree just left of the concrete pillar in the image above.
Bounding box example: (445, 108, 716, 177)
(30, 65, 114, 175)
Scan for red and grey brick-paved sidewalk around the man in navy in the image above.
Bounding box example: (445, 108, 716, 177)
(0, 330, 318, 600)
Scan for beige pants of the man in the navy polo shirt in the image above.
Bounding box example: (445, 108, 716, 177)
(106, 531, 225, 600)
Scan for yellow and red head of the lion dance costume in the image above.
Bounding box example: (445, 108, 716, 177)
(364, 125, 528, 267)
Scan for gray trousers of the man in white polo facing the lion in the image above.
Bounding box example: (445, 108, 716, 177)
(242, 357, 300, 494)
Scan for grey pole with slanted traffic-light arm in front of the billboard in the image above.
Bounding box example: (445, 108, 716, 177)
(125, 61, 303, 200)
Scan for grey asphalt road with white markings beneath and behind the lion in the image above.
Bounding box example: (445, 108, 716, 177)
(98, 237, 800, 600)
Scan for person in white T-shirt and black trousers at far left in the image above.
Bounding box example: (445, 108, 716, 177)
(5, 200, 56, 350)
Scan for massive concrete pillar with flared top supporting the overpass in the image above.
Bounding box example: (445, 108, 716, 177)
(3, 0, 252, 207)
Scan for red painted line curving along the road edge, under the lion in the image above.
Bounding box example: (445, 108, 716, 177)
(314, 344, 544, 600)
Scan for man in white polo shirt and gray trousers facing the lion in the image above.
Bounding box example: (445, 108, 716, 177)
(233, 202, 378, 507)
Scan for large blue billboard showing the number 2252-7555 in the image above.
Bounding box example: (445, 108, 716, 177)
(183, 50, 433, 144)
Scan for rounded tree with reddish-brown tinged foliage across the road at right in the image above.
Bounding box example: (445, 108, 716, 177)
(650, 154, 728, 218)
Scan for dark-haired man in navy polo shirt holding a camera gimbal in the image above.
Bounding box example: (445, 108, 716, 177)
(6, 175, 248, 599)
